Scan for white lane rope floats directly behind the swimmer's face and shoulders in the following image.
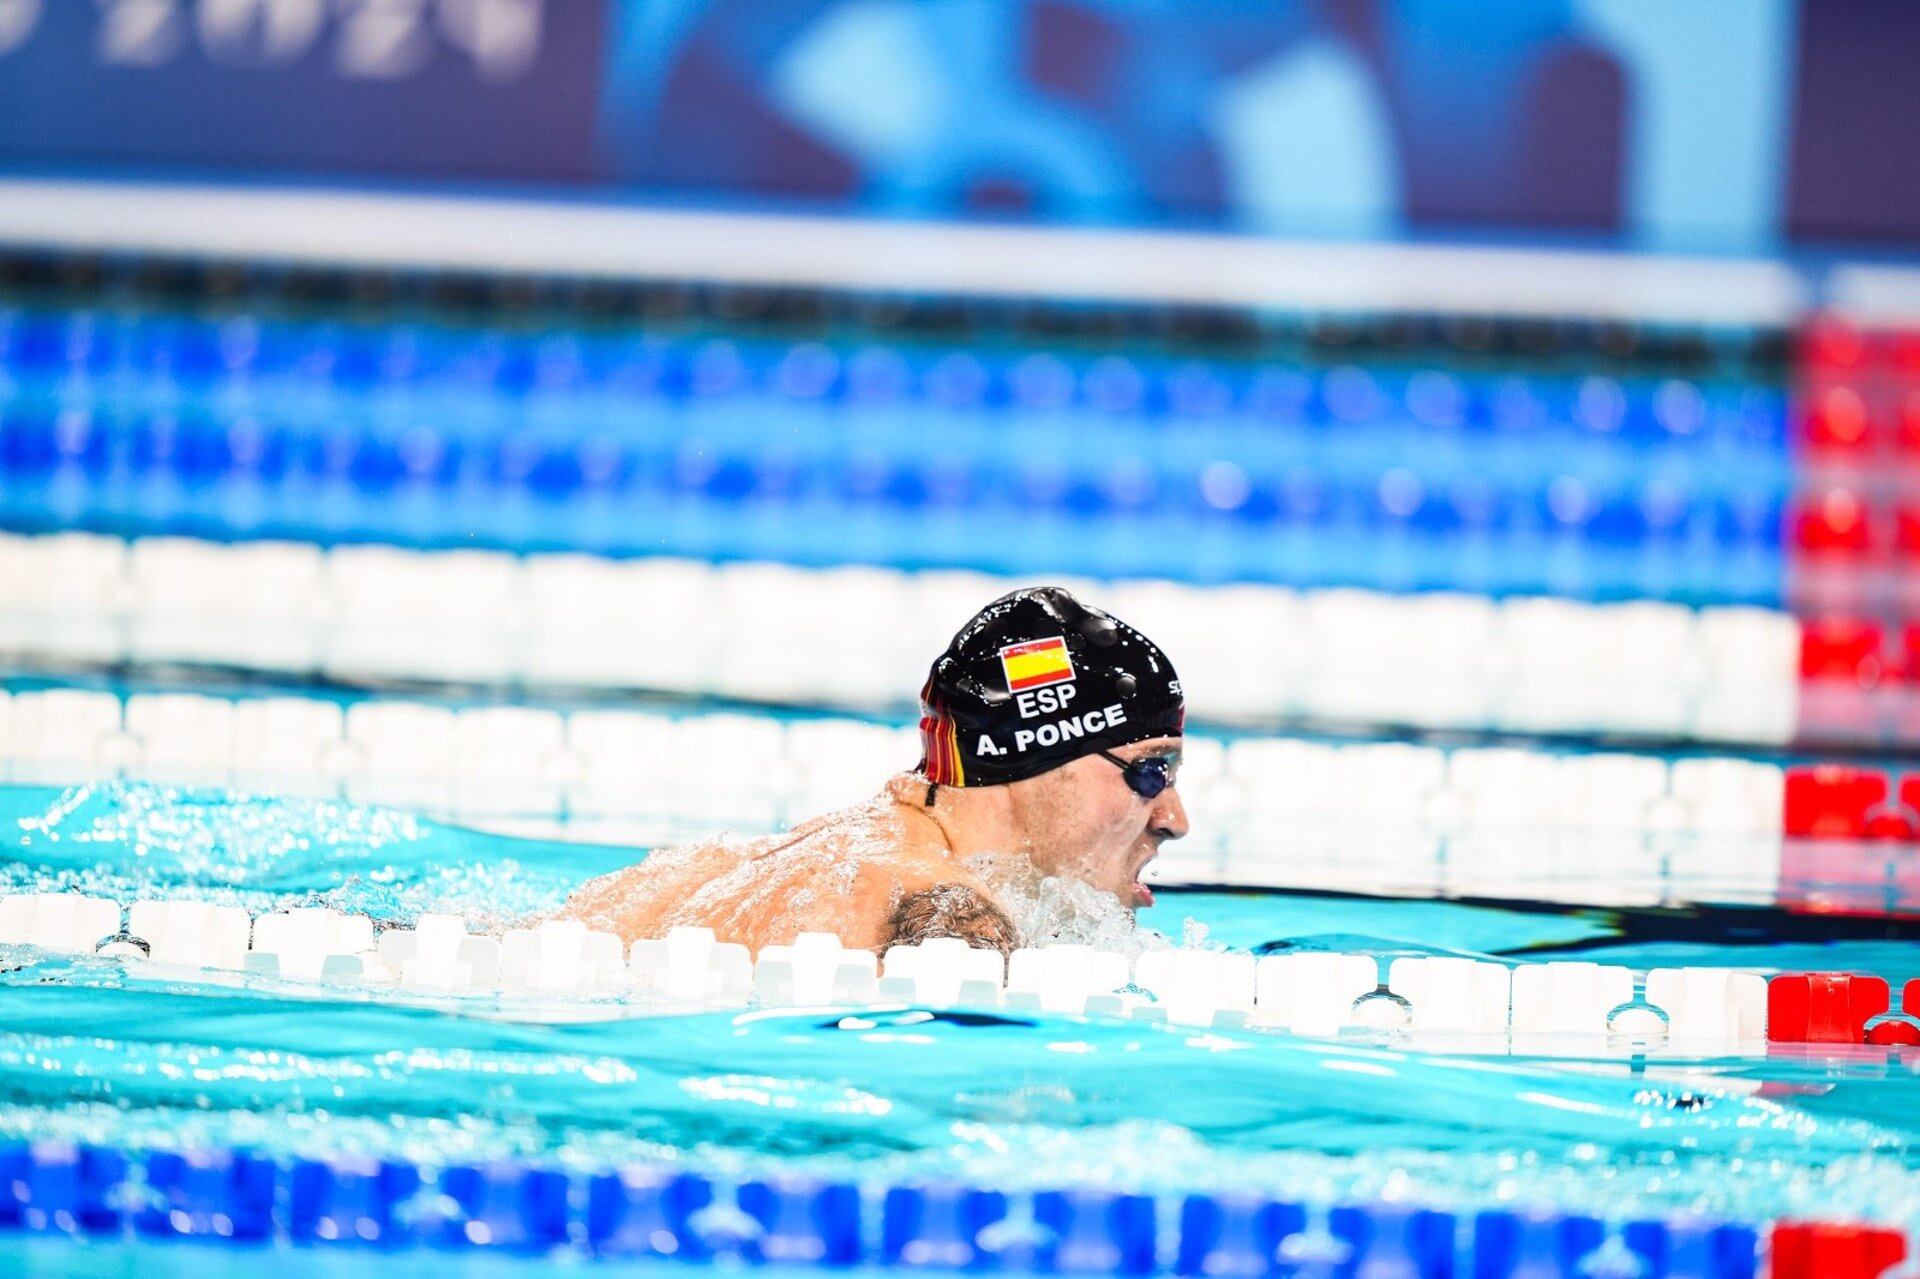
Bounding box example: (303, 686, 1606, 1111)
(0, 688, 1786, 905)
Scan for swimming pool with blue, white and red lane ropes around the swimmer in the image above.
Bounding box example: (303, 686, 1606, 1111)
(0, 241, 1920, 1279)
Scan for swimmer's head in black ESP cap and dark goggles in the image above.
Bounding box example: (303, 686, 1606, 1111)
(920, 586, 1187, 905)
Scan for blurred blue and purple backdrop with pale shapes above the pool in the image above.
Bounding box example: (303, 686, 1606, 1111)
(0, 0, 1920, 252)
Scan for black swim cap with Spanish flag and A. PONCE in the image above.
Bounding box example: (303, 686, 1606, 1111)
(920, 586, 1187, 785)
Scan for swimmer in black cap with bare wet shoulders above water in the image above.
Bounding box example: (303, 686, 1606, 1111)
(563, 586, 1187, 951)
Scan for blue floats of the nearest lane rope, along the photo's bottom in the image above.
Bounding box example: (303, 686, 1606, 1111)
(0, 1143, 1761, 1279)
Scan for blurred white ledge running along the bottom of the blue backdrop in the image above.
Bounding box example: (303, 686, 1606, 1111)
(0, 181, 1807, 325)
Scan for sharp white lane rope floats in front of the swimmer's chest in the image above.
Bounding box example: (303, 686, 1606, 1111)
(0, 893, 1766, 1056)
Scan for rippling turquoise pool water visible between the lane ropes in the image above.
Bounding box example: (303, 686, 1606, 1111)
(0, 785, 1920, 1225)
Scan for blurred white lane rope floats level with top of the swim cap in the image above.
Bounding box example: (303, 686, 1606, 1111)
(0, 534, 1799, 743)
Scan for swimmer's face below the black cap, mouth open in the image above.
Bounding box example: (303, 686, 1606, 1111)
(1008, 737, 1187, 908)
